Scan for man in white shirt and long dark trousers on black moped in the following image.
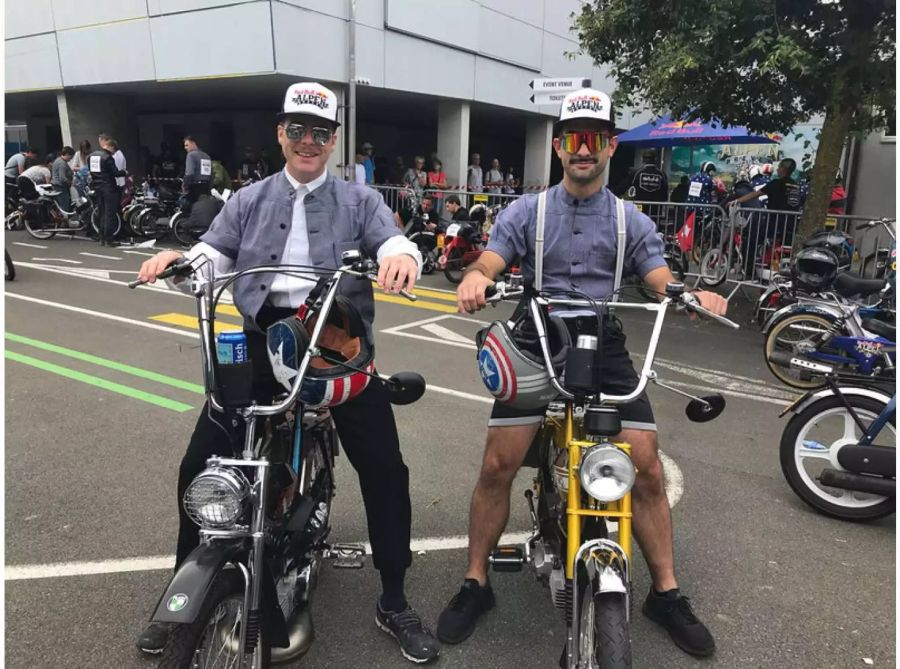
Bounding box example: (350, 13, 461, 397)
(138, 82, 440, 662)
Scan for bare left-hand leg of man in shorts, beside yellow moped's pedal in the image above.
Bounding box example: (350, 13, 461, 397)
(466, 423, 540, 585)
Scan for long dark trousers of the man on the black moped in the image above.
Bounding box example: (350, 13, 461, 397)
(175, 328, 412, 574)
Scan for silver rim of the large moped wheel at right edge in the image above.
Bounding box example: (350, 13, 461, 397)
(794, 407, 896, 509)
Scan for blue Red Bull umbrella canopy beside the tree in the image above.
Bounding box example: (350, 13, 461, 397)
(619, 116, 781, 147)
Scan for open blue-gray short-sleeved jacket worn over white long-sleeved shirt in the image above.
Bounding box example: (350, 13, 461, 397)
(200, 172, 402, 341)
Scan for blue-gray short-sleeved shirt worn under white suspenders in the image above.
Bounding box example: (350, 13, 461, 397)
(487, 184, 666, 299)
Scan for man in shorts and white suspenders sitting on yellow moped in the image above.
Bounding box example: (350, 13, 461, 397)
(437, 88, 727, 656)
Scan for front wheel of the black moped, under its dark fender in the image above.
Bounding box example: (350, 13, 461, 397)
(158, 569, 272, 669)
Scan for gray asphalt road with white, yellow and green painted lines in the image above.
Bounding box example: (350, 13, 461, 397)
(5, 233, 896, 669)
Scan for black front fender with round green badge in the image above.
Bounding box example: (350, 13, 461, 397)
(150, 540, 243, 624)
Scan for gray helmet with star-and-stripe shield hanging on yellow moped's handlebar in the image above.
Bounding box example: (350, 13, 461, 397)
(475, 317, 571, 410)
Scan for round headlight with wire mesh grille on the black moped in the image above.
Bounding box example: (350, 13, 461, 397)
(184, 467, 250, 529)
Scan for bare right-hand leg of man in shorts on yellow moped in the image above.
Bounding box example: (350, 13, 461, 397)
(615, 429, 678, 592)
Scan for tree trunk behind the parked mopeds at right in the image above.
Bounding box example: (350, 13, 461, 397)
(794, 0, 880, 247)
